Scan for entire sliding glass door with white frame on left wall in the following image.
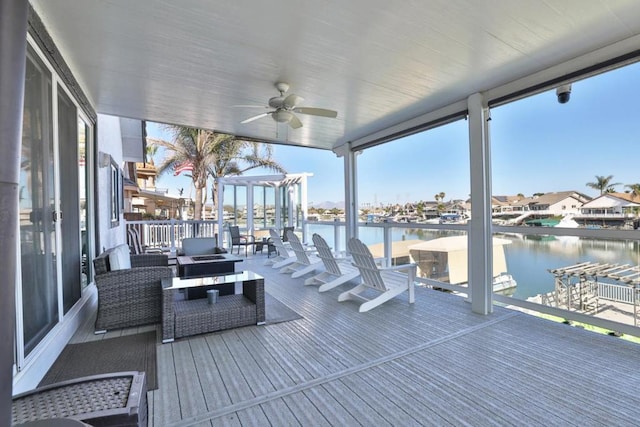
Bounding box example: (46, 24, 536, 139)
(16, 45, 93, 362)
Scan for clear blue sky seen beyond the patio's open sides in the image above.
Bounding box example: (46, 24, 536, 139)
(147, 64, 640, 205)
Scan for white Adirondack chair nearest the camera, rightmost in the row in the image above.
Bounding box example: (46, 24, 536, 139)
(338, 238, 417, 313)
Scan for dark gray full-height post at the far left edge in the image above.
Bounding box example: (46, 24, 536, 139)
(0, 0, 28, 426)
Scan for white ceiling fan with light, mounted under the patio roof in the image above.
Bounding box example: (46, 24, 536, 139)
(235, 82, 338, 129)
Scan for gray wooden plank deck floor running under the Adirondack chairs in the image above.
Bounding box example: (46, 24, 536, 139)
(72, 256, 640, 427)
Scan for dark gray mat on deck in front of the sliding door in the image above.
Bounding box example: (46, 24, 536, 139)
(39, 331, 158, 390)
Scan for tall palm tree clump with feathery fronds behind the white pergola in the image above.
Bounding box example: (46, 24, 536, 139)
(150, 125, 286, 219)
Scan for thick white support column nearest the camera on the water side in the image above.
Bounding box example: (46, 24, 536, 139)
(467, 93, 493, 314)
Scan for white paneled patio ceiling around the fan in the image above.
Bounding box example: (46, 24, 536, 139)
(31, 0, 640, 149)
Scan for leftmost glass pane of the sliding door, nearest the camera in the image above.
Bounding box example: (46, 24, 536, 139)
(19, 47, 58, 355)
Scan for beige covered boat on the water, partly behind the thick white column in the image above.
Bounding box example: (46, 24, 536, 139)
(409, 236, 517, 292)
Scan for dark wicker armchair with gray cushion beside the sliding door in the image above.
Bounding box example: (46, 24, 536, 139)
(93, 248, 173, 333)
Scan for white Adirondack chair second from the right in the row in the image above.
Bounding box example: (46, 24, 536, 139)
(304, 234, 360, 292)
